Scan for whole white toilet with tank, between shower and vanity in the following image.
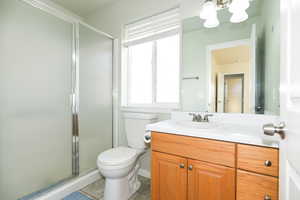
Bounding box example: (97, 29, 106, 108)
(97, 113, 157, 200)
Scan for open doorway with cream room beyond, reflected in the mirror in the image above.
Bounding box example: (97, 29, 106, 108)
(208, 44, 251, 113)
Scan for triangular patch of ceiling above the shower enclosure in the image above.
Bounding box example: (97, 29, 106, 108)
(52, 0, 117, 17)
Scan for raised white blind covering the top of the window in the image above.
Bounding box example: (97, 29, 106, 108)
(123, 8, 180, 46)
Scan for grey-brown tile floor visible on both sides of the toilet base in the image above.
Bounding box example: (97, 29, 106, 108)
(72, 176, 151, 200)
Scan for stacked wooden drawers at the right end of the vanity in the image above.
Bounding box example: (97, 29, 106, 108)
(236, 144, 279, 200)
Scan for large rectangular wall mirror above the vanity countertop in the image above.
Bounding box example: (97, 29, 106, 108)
(181, 0, 280, 115)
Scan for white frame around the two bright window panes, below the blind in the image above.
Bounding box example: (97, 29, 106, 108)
(122, 32, 182, 110)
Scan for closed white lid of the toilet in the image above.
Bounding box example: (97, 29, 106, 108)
(98, 147, 137, 165)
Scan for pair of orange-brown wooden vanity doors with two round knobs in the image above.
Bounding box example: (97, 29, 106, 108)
(152, 151, 235, 200)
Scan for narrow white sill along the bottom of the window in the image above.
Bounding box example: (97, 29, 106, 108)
(120, 106, 180, 114)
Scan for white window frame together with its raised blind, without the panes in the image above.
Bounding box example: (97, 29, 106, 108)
(120, 5, 182, 110)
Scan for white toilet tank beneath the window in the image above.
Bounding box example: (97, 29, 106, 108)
(124, 113, 157, 149)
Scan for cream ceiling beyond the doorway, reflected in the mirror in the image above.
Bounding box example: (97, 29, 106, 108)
(213, 45, 250, 65)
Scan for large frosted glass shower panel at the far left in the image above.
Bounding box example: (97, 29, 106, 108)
(0, 0, 73, 200)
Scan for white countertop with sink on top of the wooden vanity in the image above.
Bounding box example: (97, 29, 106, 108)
(146, 120, 280, 148)
